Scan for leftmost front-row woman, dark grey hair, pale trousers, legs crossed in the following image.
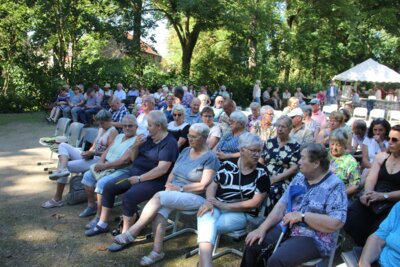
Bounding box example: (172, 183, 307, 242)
(42, 110, 118, 209)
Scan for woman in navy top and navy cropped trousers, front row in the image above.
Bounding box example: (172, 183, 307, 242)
(85, 110, 179, 236)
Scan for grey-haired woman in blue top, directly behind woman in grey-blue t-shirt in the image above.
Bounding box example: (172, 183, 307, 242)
(214, 111, 247, 160)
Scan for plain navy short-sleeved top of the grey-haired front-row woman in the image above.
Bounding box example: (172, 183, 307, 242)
(130, 133, 179, 181)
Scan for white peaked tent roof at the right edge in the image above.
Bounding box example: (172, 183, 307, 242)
(333, 58, 400, 83)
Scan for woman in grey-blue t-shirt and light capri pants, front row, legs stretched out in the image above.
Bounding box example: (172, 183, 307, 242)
(109, 123, 219, 265)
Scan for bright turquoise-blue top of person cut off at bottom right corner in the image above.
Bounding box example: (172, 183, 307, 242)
(375, 202, 400, 267)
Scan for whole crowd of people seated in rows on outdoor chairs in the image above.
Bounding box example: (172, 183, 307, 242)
(42, 84, 400, 266)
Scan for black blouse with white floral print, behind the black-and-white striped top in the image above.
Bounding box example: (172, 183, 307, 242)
(261, 137, 300, 180)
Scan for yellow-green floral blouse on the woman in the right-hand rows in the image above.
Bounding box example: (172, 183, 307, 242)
(329, 154, 361, 187)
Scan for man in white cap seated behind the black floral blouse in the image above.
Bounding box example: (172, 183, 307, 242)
(288, 108, 314, 145)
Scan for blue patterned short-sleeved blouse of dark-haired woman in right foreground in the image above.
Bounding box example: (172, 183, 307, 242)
(279, 172, 347, 257)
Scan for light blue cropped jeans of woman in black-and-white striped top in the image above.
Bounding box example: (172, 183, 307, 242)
(197, 208, 246, 245)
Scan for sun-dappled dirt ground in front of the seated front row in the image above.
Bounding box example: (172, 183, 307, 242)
(0, 114, 242, 267)
